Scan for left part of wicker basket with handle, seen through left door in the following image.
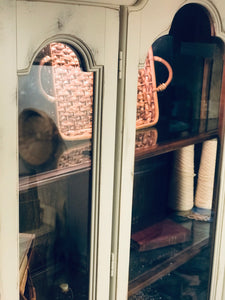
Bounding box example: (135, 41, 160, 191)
(39, 43, 93, 140)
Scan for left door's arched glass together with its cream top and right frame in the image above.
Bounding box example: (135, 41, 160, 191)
(18, 2, 118, 300)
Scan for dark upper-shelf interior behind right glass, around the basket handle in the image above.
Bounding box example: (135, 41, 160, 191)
(149, 4, 224, 142)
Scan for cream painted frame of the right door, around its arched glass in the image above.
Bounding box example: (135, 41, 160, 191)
(110, 0, 225, 300)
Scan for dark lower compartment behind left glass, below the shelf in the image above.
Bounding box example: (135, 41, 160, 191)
(19, 170, 91, 299)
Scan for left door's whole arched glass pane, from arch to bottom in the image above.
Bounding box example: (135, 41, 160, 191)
(19, 43, 94, 300)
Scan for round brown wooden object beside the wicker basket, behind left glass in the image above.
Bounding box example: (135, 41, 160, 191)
(19, 109, 58, 166)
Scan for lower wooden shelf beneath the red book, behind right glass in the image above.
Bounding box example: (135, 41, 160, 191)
(128, 221, 210, 296)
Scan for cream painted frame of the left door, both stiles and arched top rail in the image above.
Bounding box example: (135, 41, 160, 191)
(0, 1, 119, 300)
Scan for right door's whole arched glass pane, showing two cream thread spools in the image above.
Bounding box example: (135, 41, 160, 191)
(128, 5, 224, 300)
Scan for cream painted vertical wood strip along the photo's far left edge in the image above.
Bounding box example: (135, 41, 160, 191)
(0, 0, 19, 300)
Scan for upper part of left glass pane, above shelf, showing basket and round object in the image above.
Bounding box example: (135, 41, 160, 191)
(19, 43, 93, 175)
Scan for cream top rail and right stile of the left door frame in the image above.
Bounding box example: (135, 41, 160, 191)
(17, 1, 119, 300)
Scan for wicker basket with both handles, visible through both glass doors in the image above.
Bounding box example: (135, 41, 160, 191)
(39, 43, 173, 140)
